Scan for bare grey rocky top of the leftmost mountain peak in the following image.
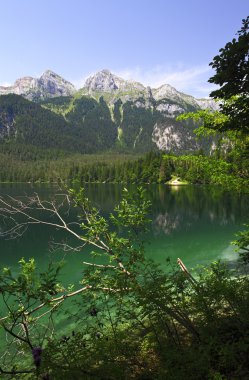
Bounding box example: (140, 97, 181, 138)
(0, 70, 76, 101)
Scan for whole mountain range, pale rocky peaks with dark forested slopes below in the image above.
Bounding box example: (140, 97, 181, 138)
(0, 70, 218, 154)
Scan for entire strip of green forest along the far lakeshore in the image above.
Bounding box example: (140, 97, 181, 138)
(0, 144, 248, 191)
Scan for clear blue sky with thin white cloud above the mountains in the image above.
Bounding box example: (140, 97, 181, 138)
(0, 0, 249, 98)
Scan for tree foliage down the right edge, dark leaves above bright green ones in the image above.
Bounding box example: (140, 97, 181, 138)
(178, 16, 249, 261)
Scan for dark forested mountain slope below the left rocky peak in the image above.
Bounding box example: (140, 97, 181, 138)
(0, 94, 116, 153)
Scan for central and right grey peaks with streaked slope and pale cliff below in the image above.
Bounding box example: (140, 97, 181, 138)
(79, 70, 218, 153)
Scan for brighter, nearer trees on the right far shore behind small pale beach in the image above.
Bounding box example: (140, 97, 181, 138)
(77, 152, 248, 187)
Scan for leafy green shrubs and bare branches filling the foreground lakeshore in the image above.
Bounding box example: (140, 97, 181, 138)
(0, 188, 249, 380)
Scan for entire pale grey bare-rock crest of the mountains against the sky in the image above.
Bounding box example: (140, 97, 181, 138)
(0, 69, 218, 109)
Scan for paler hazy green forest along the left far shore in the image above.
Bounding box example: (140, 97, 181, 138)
(0, 144, 141, 182)
